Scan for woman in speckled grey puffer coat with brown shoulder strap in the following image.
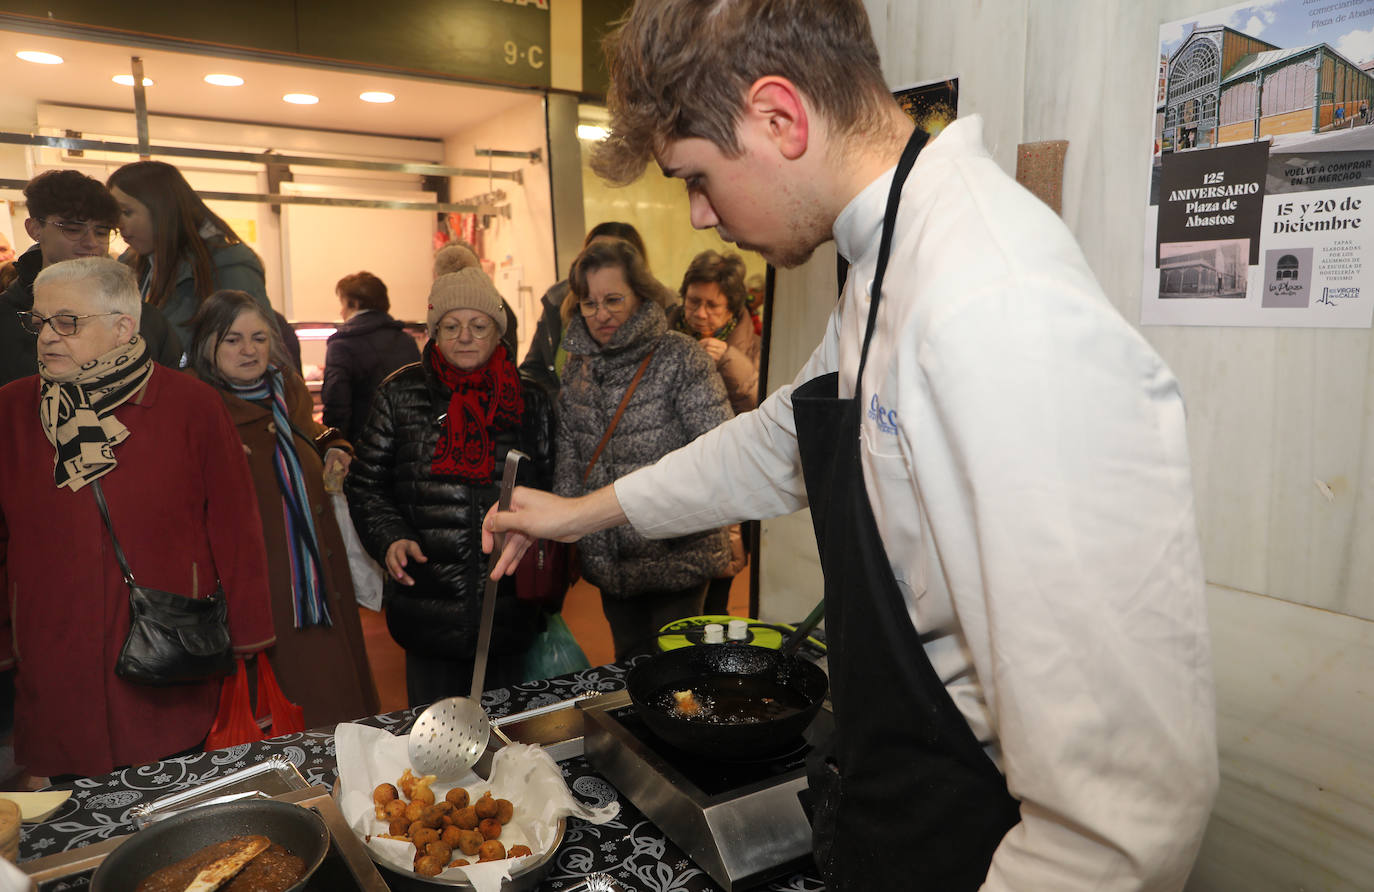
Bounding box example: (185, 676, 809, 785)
(554, 239, 732, 660)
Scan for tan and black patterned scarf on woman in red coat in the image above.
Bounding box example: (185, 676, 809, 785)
(38, 335, 153, 492)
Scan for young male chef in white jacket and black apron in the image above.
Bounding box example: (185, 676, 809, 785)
(486, 0, 1217, 892)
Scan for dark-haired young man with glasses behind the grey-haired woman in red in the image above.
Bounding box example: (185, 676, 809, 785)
(0, 170, 185, 385)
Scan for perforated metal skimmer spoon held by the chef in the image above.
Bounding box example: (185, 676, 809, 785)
(407, 449, 529, 781)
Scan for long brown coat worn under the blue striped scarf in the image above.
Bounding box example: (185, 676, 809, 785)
(220, 371, 379, 728)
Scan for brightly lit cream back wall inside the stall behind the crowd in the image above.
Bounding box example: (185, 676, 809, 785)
(0, 105, 442, 320)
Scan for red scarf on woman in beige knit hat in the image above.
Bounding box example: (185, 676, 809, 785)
(425, 342, 525, 484)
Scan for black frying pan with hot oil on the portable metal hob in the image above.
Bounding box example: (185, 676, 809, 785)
(625, 643, 830, 760)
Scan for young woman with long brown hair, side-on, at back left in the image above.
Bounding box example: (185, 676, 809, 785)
(106, 161, 272, 344)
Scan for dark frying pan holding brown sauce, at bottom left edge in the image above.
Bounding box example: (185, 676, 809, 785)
(91, 799, 330, 892)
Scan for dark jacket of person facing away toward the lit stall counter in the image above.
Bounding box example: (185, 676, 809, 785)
(320, 311, 420, 441)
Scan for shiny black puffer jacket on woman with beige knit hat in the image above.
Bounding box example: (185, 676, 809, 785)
(345, 342, 554, 660)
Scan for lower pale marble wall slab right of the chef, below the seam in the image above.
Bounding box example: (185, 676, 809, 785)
(1187, 587, 1374, 892)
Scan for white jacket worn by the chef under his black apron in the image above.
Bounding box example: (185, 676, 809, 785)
(616, 118, 1217, 892)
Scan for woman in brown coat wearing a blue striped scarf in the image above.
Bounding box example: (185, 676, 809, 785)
(191, 291, 379, 727)
